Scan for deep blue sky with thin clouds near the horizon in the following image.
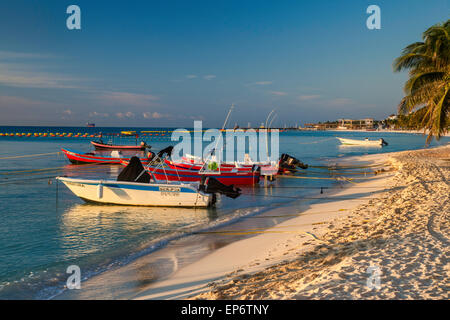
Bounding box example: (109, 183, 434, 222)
(0, 0, 450, 127)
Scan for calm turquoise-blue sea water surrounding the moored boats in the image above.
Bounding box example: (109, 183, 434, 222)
(0, 127, 450, 299)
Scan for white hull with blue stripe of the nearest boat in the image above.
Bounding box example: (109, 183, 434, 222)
(57, 177, 213, 208)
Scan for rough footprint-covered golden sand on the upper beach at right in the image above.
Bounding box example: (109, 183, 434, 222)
(181, 145, 450, 300)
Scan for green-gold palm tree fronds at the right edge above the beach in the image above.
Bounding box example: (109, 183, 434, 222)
(393, 20, 450, 143)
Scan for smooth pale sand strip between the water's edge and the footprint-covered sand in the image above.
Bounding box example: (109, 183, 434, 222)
(136, 154, 400, 299)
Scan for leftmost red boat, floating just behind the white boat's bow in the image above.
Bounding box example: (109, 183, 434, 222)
(61, 148, 154, 165)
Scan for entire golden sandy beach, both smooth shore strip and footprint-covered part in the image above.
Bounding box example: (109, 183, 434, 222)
(134, 145, 450, 299)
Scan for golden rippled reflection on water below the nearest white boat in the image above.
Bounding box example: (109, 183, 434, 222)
(60, 204, 216, 256)
